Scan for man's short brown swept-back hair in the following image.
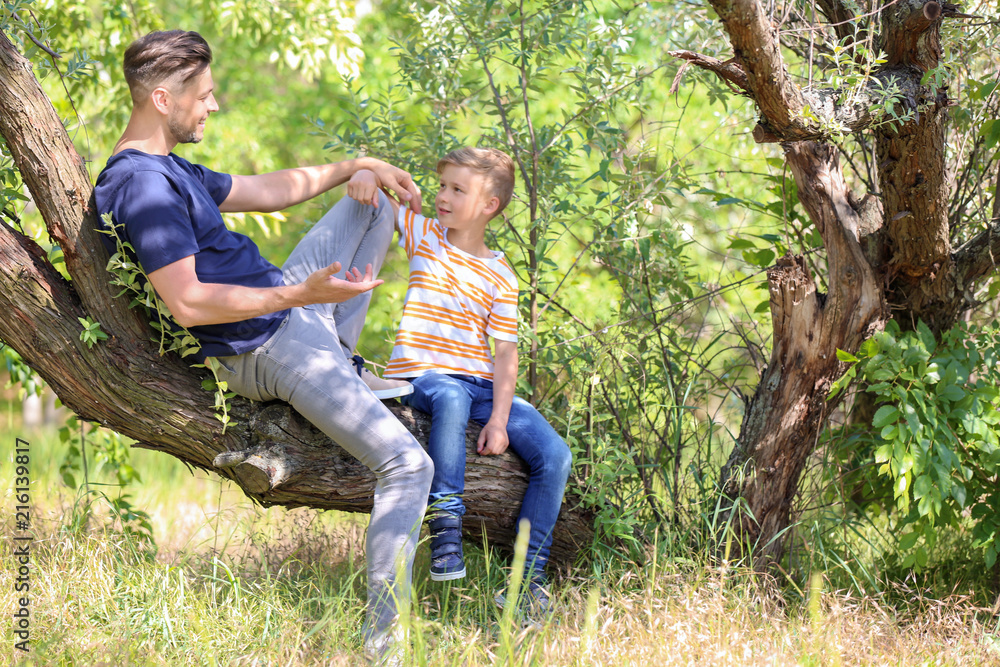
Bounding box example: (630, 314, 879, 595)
(122, 30, 212, 105)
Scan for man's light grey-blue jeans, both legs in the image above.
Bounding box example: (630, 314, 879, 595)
(217, 195, 433, 640)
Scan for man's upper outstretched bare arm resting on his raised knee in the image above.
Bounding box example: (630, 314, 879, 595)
(219, 157, 421, 213)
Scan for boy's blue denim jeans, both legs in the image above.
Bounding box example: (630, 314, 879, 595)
(399, 373, 572, 574)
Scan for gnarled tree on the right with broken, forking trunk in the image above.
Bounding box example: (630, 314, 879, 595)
(677, 0, 1000, 564)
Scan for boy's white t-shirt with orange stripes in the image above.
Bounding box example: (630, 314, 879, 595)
(383, 208, 518, 380)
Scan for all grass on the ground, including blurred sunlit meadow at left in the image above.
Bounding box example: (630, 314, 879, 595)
(0, 420, 1000, 666)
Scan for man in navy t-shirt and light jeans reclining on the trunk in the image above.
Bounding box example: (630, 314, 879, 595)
(95, 30, 433, 653)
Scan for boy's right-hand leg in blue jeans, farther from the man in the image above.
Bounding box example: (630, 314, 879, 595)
(472, 389, 573, 578)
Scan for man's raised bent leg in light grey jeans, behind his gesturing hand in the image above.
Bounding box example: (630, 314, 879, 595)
(281, 192, 395, 358)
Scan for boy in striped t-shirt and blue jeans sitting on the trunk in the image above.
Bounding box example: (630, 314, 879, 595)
(348, 148, 571, 611)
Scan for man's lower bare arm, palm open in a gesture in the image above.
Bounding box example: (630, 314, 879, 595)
(149, 255, 383, 327)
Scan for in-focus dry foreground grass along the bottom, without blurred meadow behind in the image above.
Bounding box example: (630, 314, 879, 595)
(0, 508, 1000, 667)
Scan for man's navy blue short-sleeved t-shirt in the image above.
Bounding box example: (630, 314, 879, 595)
(94, 148, 288, 361)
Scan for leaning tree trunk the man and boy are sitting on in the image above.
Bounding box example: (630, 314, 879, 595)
(0, 32, 593, 562)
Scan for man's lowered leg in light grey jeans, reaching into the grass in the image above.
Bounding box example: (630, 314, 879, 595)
(218, 308, 433, 640)
